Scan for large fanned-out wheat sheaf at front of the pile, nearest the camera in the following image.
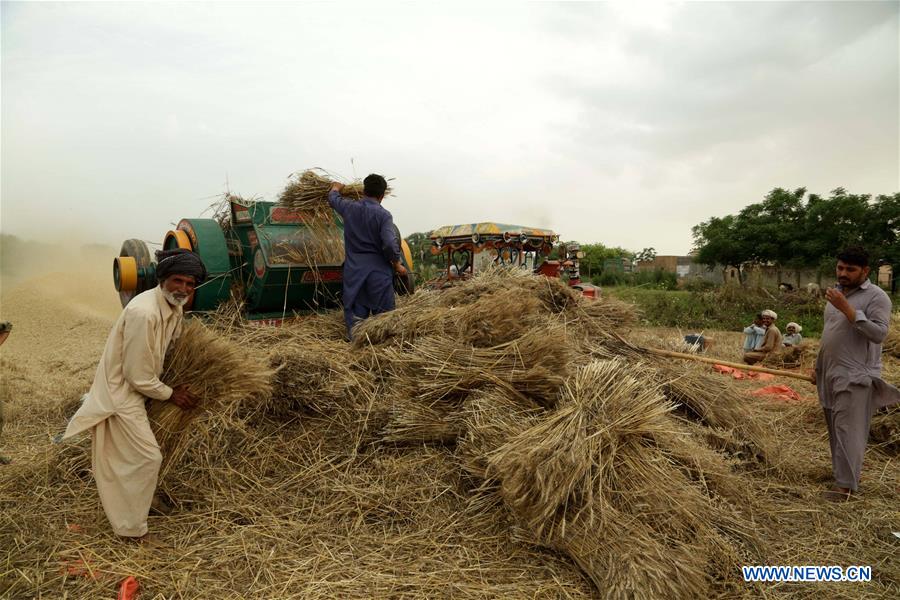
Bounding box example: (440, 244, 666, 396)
(487, 360, 755, 598)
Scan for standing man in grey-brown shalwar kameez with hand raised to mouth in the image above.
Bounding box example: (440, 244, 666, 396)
(815, 248, 900, 501)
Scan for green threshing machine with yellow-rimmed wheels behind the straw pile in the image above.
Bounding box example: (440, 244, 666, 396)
(113, 199, 413, 322)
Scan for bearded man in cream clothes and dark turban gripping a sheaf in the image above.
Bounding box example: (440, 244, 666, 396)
(63, 249, 206, 541)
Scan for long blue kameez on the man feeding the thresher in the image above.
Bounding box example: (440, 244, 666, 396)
(328, 191, 400, 307)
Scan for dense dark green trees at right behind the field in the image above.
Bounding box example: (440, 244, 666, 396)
(692, 188, 900, 288)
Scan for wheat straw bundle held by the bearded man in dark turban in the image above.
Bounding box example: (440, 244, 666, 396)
(148, 320, 273, 478)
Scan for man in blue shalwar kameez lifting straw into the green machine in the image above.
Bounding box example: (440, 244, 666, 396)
(328, 174, 406, 339)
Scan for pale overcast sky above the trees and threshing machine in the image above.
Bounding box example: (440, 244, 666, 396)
(0, 2, 900, 254)
